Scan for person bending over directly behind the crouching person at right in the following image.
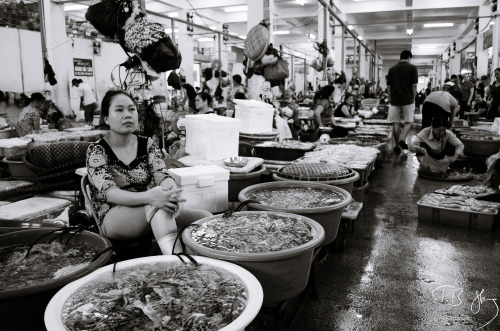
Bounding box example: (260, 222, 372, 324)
(422, 87, 459, 129)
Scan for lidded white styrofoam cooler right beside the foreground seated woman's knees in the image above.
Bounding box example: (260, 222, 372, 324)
(168, 165, 229, 213)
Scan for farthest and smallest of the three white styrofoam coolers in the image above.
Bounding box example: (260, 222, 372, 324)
(233, 99, 274, 133)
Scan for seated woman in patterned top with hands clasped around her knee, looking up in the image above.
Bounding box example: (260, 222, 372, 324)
(87, 91, 211, 254)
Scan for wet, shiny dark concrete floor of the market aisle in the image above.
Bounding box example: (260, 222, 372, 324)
(247, 136, 500, 331)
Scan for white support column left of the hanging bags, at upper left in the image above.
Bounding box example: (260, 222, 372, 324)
(40, 0, 72, 115)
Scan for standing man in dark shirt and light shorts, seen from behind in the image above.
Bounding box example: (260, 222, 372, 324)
(387, 50, 418, 154)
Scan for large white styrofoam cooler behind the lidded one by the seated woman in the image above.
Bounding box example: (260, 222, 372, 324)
(185, 114, 241, 161)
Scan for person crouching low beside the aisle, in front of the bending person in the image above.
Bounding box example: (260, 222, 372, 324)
(409, 116, 464, 173)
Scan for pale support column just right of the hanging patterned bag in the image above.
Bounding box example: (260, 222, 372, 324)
(179, 10, 194, 85)
